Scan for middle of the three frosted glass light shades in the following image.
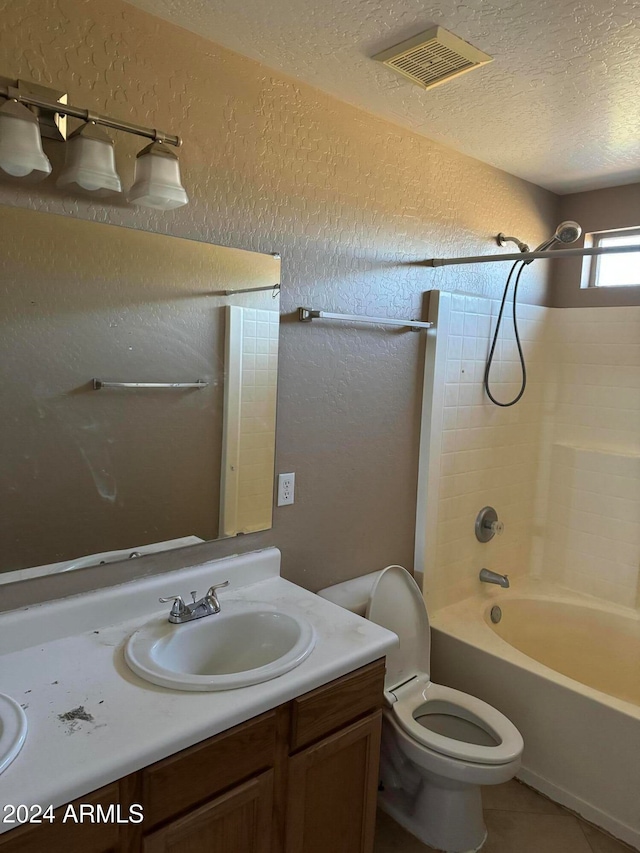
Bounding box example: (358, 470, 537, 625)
(56, 122, 122, 198)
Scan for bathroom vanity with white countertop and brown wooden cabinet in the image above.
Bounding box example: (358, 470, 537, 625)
(0, 548, 397, 853)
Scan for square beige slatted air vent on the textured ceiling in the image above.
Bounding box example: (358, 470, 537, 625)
(373, 27, 493, 89)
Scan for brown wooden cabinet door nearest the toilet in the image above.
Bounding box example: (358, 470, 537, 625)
(285, 711, 382, 853)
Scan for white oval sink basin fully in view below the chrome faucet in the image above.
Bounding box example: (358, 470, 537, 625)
(125, 601, 315, 690)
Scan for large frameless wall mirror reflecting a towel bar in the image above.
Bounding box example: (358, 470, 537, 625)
(0, 207, 280, 582)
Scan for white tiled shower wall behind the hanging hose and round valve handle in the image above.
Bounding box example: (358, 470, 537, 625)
(416, 293, 550, 609)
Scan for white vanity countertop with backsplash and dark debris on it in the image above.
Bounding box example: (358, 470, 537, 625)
(0, 548, 397, 833)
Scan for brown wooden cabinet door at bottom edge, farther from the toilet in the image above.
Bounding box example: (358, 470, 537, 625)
(142, 770, 273, 853)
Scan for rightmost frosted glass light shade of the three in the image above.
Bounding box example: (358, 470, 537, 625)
(127, 142, 189, 210)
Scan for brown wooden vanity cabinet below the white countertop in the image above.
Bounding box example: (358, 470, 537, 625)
(0, 660, 384, 853)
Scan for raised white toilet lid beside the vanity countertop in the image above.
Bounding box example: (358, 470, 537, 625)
(367, 566, 431, 691)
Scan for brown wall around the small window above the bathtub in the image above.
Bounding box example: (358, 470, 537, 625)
(550, 183, 640, 308)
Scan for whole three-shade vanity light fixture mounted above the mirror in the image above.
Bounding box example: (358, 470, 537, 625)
(0, 77, 189, 210)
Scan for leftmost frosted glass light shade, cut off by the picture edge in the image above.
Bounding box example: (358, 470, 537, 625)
(0, 101, 51, 180)
